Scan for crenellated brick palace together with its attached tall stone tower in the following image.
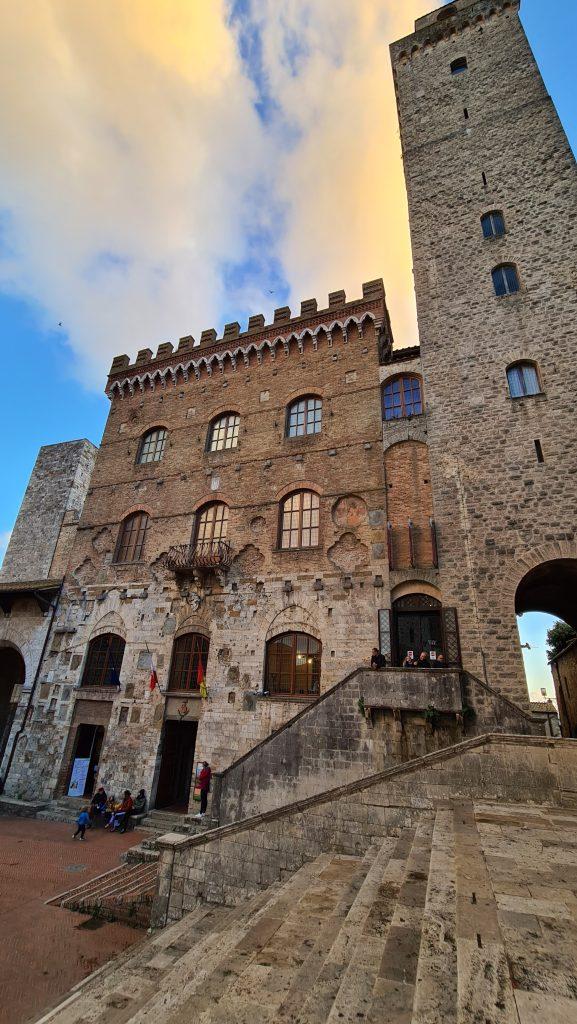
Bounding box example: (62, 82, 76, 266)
(2, 0, 577, 808)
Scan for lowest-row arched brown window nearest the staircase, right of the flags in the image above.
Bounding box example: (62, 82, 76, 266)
(264, 633, 322, 696)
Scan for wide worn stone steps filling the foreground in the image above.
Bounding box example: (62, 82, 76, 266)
(32, 801, 577, 1024)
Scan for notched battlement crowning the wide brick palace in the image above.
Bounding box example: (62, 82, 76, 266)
(107, 278, 393, 393)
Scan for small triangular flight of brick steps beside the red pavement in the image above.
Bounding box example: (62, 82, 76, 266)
(46, 854, 158, 928)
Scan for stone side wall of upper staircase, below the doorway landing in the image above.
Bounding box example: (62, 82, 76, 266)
(211, 669, 542, 824)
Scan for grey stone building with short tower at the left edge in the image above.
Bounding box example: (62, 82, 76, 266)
(0, 440, 96, 784)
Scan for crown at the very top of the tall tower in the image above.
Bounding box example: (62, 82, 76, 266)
(390, 0, 521, 63)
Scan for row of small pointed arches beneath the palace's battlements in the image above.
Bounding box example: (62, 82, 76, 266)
(107, 311, 377, 397)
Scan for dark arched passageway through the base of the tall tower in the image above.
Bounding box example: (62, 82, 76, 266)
(514, 558, 577, 736)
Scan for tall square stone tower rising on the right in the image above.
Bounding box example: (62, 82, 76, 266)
(390, 0, 577, 701)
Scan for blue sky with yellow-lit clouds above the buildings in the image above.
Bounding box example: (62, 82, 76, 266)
(0, 0, 577, 690)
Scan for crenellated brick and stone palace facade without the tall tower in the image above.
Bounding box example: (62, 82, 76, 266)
(6, 281, 424, 806)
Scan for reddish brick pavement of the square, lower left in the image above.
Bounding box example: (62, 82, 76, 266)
(0, 817, 142, 1024)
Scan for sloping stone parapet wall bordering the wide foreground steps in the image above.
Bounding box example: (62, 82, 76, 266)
(153, 736, 577, 927)
